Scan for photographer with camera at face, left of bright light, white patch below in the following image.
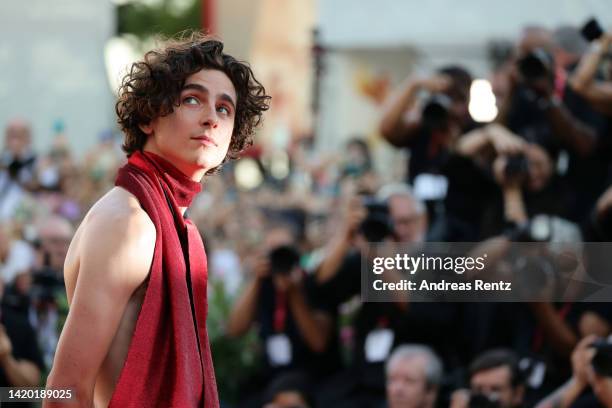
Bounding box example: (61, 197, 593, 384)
(379, 66, 475, 220)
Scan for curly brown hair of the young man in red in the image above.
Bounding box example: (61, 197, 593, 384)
(115, 32, 270, 174)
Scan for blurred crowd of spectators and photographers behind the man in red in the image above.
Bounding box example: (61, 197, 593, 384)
(0, 24, 612, 408)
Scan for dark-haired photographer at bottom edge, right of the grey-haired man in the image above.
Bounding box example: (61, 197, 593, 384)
(450, 349, 525, 408)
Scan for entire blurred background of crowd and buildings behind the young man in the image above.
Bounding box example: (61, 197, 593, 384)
(0, 0, 612, 408)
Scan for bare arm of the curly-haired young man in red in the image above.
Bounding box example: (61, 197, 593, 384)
(44, 206, 156, 408)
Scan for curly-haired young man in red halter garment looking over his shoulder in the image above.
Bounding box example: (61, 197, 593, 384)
(45, 34, 269, 408)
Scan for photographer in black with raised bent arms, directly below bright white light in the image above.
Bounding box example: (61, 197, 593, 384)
(436, 123, 568, 242)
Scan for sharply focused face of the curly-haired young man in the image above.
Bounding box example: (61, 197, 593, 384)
(141, 69, 237, 181)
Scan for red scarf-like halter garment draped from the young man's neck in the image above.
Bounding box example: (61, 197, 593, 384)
(109, 152, 219, 408)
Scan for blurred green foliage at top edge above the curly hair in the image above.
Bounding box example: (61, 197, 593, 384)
(117, 0, 202, 40)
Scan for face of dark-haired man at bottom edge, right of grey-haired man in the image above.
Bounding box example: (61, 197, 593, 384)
(470, 366, 523, 408)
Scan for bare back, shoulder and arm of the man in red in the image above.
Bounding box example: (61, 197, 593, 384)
(48, 187, 155, 407)
